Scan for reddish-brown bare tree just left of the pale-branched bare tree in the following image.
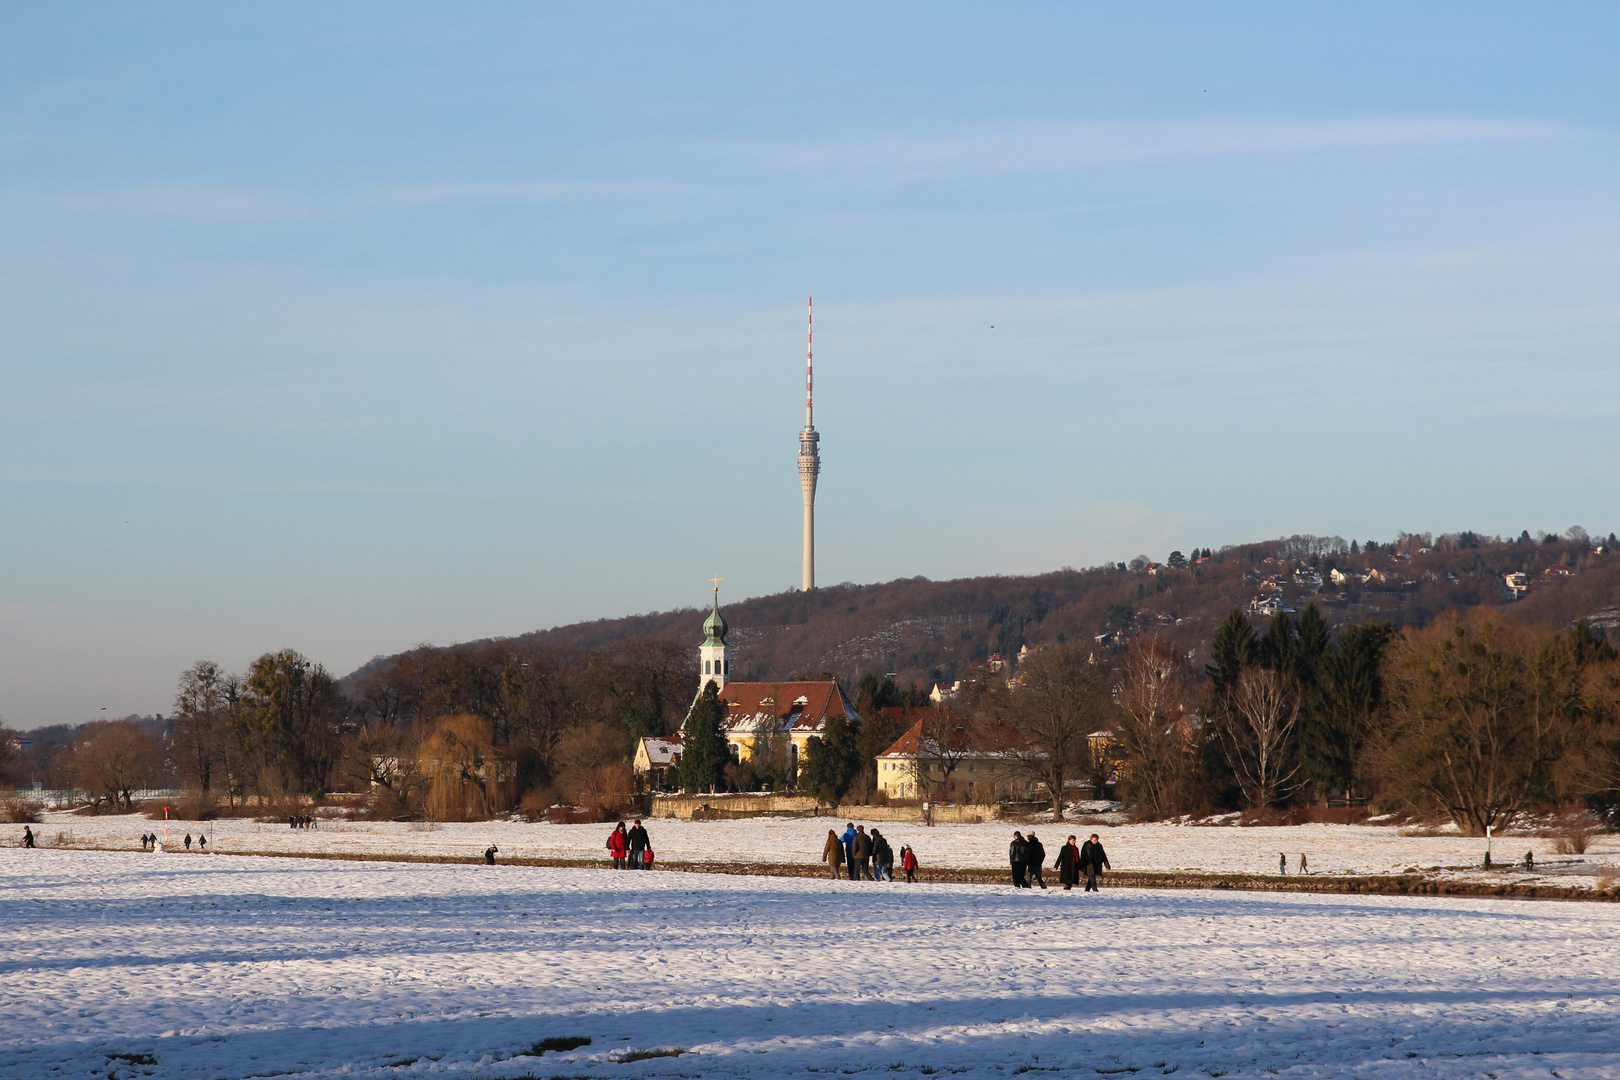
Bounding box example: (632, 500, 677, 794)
(1113, 635, 1192, 818)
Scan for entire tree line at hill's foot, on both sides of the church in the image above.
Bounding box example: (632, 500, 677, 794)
(15, 606, 1620, 834)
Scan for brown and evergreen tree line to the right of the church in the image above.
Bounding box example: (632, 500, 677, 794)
(745, 606, 1620, 836)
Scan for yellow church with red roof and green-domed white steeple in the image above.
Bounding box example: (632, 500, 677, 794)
(680, 586, 857, 787)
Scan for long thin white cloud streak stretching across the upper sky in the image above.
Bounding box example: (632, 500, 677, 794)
(0, 117, 1591, 225)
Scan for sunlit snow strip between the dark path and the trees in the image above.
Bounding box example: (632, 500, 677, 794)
(34, 813, 1620, 887)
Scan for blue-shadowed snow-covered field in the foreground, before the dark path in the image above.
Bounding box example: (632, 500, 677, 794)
(0, 854, 1620, 1080)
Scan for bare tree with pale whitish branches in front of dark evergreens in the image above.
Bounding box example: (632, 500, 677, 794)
(1215, 667, 1301, 810)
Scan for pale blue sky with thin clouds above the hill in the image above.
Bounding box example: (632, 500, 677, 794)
(0, 3, 1620, 727)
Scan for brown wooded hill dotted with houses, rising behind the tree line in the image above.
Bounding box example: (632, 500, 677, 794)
(343, 529, 1620, 687)
